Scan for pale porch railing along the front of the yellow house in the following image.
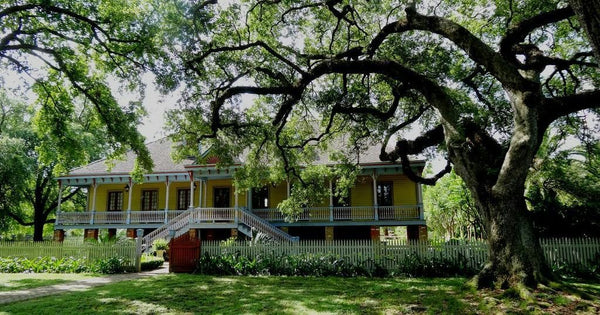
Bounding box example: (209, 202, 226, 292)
(56, 205, 422, 225)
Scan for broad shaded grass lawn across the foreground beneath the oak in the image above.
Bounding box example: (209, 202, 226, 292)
(0, 274, 600, 314)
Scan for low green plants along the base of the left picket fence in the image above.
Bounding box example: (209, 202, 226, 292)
(0, 257, 89, 273)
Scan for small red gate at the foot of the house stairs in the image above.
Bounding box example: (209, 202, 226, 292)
(169, 233, 200, 273)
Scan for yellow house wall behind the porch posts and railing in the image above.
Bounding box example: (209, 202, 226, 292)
(88, 175, 417, 211)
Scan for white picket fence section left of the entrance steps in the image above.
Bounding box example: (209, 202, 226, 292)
(0, 241, 136, 266)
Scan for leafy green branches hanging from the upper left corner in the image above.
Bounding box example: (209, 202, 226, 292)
(0, 0, 164, 171)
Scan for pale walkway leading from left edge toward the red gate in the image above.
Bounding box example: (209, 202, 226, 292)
(0, 263, 169, 304)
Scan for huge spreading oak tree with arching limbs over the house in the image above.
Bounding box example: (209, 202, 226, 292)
(165, 0, 600, 287)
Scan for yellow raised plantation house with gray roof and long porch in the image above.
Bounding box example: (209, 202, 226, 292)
(55, 139, 427, 244)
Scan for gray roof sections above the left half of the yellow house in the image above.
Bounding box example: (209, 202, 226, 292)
(69, 138, 193, 176)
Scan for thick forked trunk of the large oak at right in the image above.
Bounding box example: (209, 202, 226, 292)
(445, 91, 553, 288)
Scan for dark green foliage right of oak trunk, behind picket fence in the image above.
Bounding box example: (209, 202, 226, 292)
(526, 132, 600, 237)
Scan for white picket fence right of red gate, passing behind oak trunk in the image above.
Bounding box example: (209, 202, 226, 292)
(201, 238, 600, 269)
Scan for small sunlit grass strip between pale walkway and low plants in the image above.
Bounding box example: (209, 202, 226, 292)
(0, 273, 92, 292)
